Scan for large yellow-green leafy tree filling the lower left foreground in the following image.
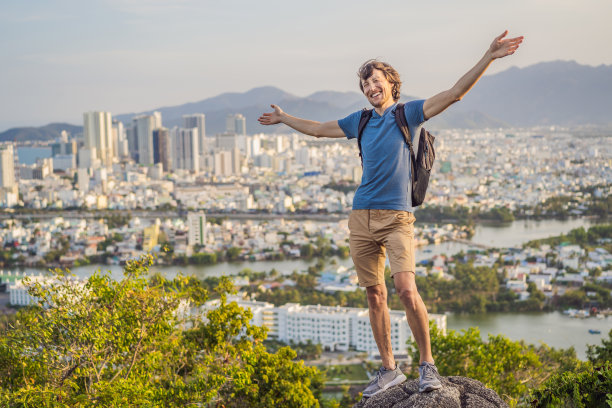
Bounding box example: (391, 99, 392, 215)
(0, 256, 322, 408)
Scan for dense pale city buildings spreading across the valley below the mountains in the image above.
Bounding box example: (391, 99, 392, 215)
(0, 112, 612, 342)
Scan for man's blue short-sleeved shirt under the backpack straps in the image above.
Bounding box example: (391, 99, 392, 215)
(338, 100, 425, 212)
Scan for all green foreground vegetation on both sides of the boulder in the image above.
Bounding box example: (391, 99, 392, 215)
(0, 256, 612, 408)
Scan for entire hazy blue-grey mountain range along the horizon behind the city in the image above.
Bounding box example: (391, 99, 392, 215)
(0, 61, 612, 141)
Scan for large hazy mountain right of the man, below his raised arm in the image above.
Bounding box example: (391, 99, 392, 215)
(460, 61, 612, 126)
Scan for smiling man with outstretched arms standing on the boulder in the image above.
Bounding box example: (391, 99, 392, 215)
(258, 31, 523, 397)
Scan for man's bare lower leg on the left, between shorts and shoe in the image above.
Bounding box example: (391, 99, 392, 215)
(366, 283, 395, 370)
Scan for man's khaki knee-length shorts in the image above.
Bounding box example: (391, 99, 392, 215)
(348, 210, 415, 287)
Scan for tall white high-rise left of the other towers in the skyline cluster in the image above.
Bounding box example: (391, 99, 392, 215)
(83, 112, 115, 167)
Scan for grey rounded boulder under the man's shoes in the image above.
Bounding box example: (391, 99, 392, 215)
(353, 377, 508, 408)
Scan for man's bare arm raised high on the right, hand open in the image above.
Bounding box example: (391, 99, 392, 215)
(423, 30, 523, 119)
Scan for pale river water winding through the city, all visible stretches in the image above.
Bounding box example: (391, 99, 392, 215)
(3, 219, 612, 359)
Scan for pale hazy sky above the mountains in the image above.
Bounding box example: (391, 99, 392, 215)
(0, 0, 612, 131)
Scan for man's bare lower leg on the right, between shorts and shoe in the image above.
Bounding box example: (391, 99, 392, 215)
(394, 272, 434, 363)
